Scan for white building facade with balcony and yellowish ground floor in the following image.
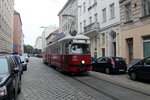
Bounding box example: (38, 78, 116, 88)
(78, 0, 121, 58)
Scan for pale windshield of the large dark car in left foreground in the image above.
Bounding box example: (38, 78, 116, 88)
(0, 58, 8, 74)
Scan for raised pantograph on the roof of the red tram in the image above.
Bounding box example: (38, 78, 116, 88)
(62, 14, 77, 36)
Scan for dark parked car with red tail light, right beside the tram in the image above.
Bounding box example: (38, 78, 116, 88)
(92, 57, 127, 74)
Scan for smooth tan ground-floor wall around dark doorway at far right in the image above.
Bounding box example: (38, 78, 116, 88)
(121, 24, 150, 63)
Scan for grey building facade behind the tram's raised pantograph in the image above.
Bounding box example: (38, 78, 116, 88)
(58, 0, 78, 35)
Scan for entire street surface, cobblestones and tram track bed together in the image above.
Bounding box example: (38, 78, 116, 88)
(18, 57, 150, 100)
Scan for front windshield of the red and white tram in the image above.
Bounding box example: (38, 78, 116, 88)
(71, 43, 90, 54)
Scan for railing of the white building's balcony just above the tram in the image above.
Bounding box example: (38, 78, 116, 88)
(84, 22, 100, 33)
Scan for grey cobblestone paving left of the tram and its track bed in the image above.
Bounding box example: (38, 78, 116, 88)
(17, 57, 95, 100)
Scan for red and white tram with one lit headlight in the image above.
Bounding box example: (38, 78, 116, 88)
(43, 35, 92, 72)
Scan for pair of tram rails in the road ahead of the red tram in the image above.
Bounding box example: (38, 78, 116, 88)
(71, 75, 150, 100)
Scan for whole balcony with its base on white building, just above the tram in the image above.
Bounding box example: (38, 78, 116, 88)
(84, 22, 100, 35)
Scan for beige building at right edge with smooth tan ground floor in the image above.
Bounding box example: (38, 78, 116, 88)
(120, 0, 150, 64)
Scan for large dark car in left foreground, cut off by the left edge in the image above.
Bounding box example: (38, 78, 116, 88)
(0, 55, 21, 100)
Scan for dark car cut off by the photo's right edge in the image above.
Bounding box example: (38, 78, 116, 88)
(128, 57, 150, 80)
